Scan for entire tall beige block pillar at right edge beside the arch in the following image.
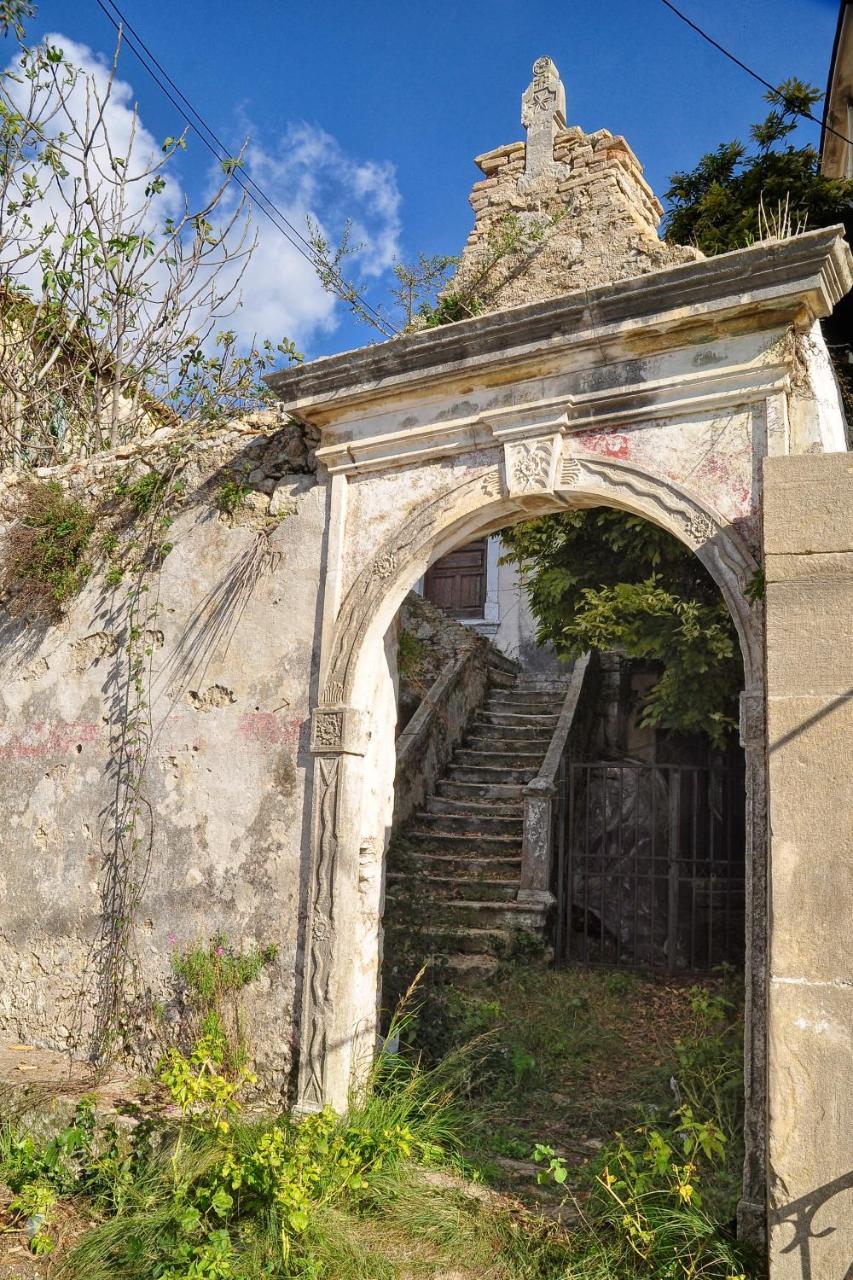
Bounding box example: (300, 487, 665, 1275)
(763, 453, 853, 1280)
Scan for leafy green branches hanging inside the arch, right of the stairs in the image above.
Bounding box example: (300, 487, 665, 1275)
(502, 508, 743, 746)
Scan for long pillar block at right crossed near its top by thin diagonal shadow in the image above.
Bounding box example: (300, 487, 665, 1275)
(767, 694, 853, 983)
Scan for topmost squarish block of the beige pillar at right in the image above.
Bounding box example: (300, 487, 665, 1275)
(763, 453, 853, 556)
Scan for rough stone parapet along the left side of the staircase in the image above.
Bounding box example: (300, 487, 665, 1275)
(393, 644, 488, 827)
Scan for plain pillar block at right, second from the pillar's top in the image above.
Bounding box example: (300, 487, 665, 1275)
(766, 573, 853, 695)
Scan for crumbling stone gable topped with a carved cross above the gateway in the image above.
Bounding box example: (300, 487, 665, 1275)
(450, 58, 702, 311)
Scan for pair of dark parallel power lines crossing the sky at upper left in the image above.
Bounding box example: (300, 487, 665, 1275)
(96, 0, 398, 337)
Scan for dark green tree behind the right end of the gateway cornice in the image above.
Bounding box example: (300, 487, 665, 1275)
(665, 78, 853, 253)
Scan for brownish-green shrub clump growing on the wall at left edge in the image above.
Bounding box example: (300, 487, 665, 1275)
(0, 480, 95, 622)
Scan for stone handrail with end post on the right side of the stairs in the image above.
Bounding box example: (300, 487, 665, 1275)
(517, 653, 590, 911)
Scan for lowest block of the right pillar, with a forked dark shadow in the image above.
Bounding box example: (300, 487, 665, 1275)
(768, 982, 853, 1280)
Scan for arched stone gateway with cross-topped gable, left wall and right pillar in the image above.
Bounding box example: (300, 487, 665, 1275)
(0, 58, 853, 1280)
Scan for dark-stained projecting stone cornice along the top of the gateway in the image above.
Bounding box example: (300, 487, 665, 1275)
(268, 227, 853, 425)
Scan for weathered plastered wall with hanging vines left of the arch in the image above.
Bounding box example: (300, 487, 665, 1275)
(0, 417, 328, 1087)
